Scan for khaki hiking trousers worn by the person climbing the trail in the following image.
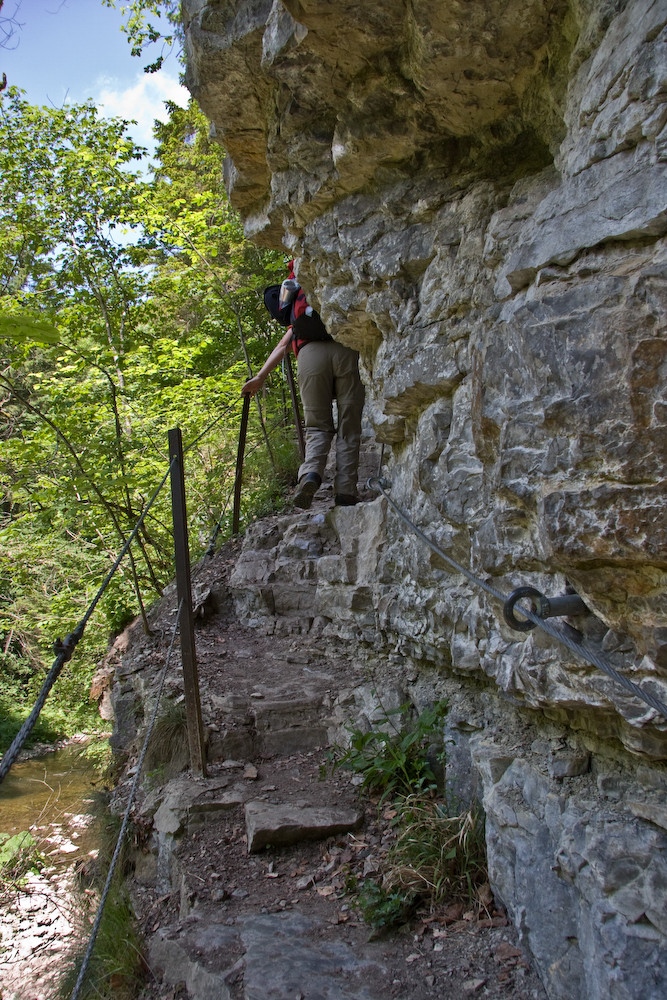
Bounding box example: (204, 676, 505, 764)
(297, 340, 364, 496)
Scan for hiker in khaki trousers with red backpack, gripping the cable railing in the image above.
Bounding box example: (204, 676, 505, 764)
(241, 261, 364, 510)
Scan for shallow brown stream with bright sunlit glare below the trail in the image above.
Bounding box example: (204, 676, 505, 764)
(0, 743, 105, 1000)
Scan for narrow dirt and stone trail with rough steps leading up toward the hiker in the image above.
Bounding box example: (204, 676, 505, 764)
(119, 470, 546, 1000)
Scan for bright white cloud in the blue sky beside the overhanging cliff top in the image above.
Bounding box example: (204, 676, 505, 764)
(94, 70, 190, 153)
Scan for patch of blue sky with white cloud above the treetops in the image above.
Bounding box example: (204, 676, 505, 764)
(0, 0, 188, 147)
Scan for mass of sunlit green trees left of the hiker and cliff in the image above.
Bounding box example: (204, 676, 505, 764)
(0, 92, 297, 742)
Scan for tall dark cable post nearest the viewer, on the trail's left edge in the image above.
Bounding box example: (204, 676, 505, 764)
(169, 427, 206, 778)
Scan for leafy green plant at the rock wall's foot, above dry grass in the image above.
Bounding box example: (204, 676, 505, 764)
(331, 701, 447, 802)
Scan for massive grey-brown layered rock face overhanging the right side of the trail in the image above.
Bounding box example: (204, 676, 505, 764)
(183, 0, 667, 1000)
